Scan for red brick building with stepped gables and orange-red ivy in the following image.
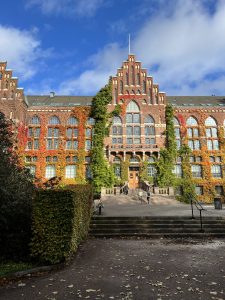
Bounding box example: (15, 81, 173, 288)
(0, 55, 225, 201)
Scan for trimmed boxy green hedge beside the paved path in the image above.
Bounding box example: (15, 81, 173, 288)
(31, 185, 92, 264)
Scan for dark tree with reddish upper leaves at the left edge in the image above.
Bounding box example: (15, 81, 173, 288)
(0, 112, 34, 258)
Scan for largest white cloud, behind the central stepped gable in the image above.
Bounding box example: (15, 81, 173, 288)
(55, 0, 225, 95)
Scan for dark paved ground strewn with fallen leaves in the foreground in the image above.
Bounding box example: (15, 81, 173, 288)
(0, 239, 225, 300)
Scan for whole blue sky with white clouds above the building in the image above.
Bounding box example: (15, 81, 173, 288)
(0, 0, 225, 95)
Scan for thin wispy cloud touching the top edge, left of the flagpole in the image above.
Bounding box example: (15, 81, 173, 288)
(26, 0, 104, 17)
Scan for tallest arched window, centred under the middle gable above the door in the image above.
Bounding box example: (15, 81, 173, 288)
(126, 101, 141, 144)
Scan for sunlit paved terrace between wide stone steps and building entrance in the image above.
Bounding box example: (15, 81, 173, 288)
(99, 194, 225, 217)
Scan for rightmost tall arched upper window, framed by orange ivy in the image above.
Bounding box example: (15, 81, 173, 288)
(205, 117, 219, 150)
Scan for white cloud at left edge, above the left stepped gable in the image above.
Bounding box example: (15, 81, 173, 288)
(0, 25, 48, 80)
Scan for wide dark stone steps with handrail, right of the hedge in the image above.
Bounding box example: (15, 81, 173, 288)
(89, 216, 225, 238)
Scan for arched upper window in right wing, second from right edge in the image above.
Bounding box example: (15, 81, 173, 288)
(186, 116, 201, 150)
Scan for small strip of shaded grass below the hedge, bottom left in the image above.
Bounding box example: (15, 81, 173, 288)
(0, 261, 33, 277)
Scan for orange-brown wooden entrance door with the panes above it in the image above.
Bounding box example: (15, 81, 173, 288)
(128, 156, 140, 189)
